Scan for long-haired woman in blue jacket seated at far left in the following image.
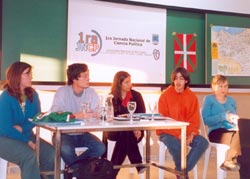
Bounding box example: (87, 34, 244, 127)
(0, 62, 54, 179)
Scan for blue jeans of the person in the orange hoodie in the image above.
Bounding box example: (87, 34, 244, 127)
(160, 134, 208, 172)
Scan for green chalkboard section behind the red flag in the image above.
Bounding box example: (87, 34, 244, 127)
(166, 10, 205, 84)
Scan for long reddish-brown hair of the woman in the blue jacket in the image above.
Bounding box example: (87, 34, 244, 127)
(3, 62, 34, 102)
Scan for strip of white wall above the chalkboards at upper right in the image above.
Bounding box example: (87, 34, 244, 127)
(128, 0, 250, 14)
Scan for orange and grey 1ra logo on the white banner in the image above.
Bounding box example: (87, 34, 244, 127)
(75, 30, 102, 56)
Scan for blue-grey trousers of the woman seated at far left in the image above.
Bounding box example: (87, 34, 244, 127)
(0, 136, 54, 179)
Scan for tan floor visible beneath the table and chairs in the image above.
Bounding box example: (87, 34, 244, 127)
(7, 150, 239, 179)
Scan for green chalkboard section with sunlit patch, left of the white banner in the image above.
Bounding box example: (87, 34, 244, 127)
(1, 0, 67, 81)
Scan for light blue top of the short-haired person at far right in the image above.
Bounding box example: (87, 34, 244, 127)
(202, 94, 237, 133)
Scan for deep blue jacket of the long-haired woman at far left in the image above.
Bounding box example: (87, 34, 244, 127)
(0, 90, 41, 142)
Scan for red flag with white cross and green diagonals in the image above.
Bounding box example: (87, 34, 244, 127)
(174, 33, 197, 72)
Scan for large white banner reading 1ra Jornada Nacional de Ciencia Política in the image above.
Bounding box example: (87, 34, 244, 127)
(67, 0, 166, 83)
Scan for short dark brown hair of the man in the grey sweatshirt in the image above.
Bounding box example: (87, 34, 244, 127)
(67, 63, 88, 85)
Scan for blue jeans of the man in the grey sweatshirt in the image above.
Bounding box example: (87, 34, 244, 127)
(58, 132, 106, 164)
